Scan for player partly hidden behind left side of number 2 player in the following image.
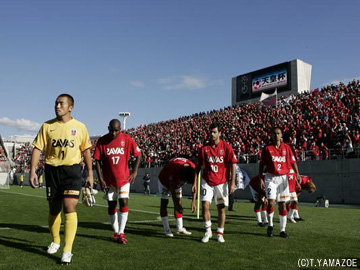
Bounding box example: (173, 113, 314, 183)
(249, 175, 269, 227)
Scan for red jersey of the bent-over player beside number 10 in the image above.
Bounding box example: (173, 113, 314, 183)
(159, 158, 195, 189)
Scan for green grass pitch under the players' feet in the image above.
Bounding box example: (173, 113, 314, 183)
(0, 186, 360, 270)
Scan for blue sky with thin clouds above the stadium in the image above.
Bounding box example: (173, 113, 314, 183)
(0, 0, 360, 139)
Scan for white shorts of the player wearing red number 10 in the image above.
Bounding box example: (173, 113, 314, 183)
(201, 179, 229, 206)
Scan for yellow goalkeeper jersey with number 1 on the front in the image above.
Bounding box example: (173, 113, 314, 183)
(33, 118, 91, 167)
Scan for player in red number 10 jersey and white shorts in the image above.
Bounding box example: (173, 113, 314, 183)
(192, 122, 237, 243)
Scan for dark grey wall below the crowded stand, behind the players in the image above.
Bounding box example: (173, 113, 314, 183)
(10, 159, 360, 205)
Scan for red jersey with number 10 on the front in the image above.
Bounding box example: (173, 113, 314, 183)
(197, 140, 237, 186)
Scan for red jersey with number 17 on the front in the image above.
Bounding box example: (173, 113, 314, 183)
(94, 133, 141, 187)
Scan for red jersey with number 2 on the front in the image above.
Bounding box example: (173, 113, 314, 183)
(260, 142, 296, 175)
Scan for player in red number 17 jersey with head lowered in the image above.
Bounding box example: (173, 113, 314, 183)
(94, 119, 141, 244)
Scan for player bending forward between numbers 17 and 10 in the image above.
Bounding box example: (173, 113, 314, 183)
(158, 157, 196, 237)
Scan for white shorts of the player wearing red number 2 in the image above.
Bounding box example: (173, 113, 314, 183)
(264, 173, 290, 202)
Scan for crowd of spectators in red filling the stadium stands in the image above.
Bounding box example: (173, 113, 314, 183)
(8, 80, 360, 169)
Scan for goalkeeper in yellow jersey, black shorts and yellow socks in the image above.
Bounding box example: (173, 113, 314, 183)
(29, 94, 93, 264)
